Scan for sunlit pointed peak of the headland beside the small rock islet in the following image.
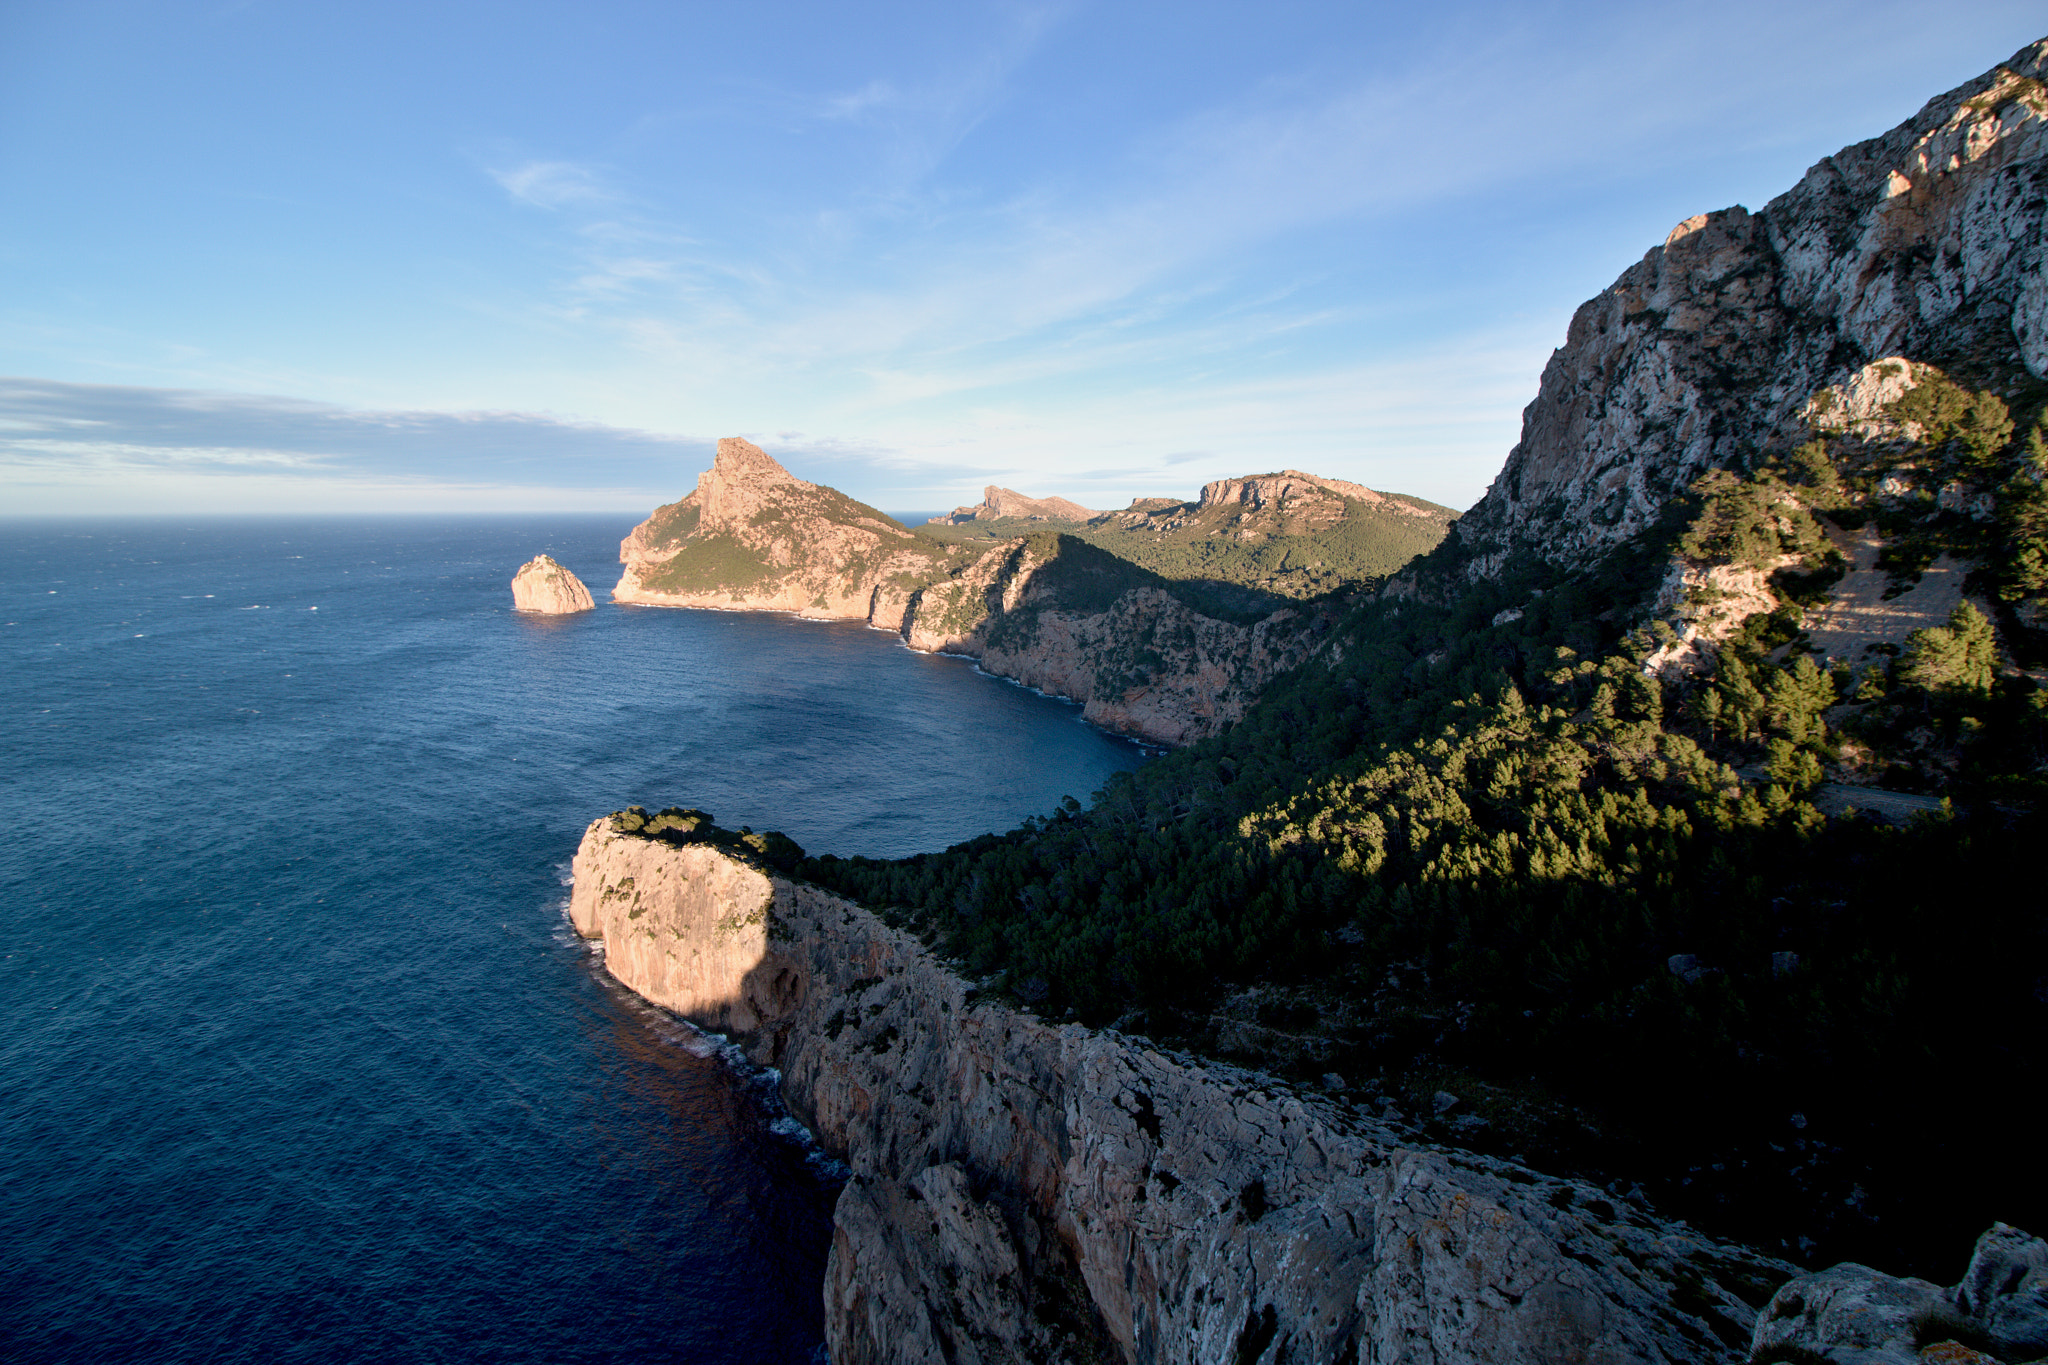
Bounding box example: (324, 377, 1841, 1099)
(612, 438, 946, 628)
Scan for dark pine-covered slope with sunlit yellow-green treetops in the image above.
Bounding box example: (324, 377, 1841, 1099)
(803, 372, 2048, 1279)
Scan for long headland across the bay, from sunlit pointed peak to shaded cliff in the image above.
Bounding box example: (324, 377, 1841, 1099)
(612, 438, 1380, 745)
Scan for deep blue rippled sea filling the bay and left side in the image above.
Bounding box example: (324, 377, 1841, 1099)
(0, 516, 1143, 1363)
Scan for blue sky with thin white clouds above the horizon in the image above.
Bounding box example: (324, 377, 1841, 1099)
(0, 0, 2048, 514)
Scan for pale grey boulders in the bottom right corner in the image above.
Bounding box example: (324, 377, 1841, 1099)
(1751, 1224, 2048, 1365)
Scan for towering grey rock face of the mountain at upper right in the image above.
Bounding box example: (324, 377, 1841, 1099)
(1456, 41, 2048, 575)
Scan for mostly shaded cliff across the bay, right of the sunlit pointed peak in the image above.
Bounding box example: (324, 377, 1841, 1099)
(903, 540, 1329, 745)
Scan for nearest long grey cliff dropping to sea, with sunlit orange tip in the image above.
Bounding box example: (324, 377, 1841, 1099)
(575, 821, 1790, 1365)
